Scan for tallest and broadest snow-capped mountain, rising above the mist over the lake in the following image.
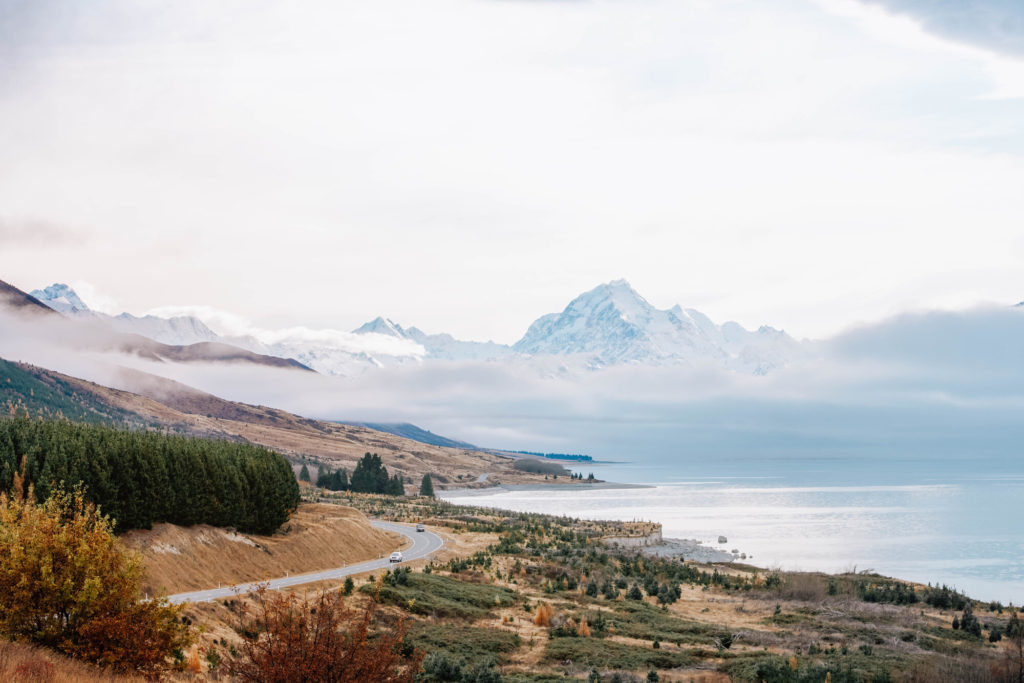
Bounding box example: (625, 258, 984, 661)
(512, 280, 800, 375)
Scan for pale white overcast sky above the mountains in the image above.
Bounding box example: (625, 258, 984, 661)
(0, 0, 1024, 342)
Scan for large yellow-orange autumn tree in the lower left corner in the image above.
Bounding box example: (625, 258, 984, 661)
(0, 476, 191, 672)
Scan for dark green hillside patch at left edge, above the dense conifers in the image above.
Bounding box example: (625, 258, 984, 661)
(0, 358, 146, 425)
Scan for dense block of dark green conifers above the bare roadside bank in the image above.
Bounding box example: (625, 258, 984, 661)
(0, 419, 299, 533)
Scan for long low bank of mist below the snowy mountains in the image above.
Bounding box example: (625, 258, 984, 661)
(0, 308, 1024, 475)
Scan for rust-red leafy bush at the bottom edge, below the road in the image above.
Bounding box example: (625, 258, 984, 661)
(226, 588, 423, 683)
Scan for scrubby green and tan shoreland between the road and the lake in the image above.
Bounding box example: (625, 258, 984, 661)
(307, 496, 1024, 683)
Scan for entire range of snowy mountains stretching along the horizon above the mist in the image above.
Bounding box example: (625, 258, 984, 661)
(25, 280, 808, 376)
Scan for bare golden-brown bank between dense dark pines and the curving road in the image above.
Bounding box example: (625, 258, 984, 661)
(122, 504, 406, 595)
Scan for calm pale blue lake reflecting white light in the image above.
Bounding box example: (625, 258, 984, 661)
(442, 461, 1024, 604)
